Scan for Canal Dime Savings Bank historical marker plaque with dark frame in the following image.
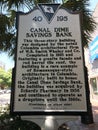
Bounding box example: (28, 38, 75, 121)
(11, 4, 87, 115)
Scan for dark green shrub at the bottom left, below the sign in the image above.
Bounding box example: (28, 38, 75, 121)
(0, 105, 41, 130)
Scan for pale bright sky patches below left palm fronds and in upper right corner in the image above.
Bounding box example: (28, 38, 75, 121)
(0, 0, 98, 70)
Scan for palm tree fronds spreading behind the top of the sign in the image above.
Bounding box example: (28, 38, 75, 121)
(0, 0, 96, 55)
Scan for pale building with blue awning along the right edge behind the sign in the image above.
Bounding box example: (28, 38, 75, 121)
(85, 4, 98, 100)
